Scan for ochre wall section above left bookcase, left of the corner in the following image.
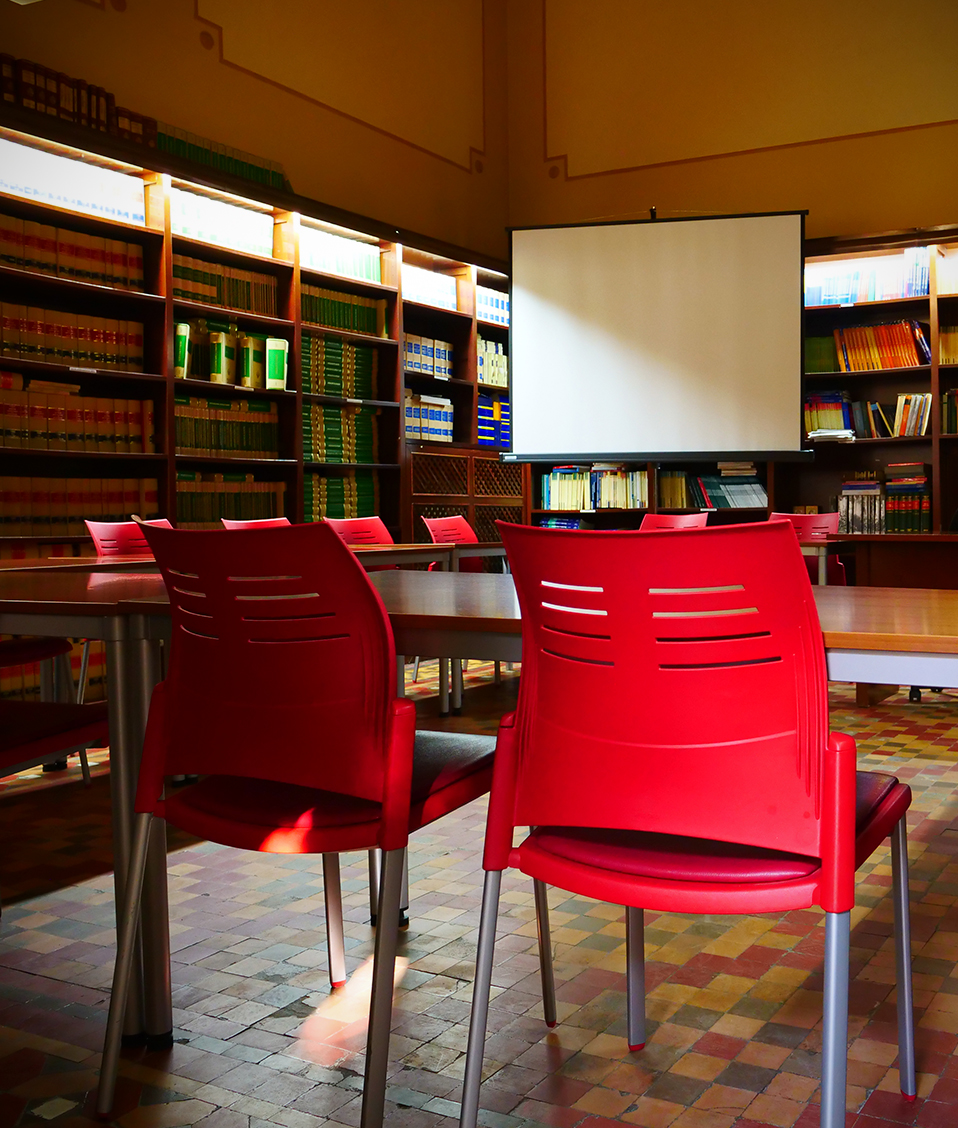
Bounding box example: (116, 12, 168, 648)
(0, 0, 507, 255)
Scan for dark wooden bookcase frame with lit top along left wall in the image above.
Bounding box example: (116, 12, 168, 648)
(0, 126, 516, 547)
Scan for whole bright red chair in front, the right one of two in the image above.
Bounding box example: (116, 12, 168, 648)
(462, 521, 915, 1128)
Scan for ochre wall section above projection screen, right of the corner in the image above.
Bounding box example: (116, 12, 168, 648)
(509, 0, 958, 242)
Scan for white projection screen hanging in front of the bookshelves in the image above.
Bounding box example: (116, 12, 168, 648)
(504, 212, 803, 461)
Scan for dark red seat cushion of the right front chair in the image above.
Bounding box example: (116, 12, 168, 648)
(530, 772, 898, 883)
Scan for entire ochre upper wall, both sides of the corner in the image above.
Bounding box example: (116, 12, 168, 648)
(0, 0, 958, 255)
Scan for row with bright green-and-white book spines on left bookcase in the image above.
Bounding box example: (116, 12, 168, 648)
(173, 317, 289, 391)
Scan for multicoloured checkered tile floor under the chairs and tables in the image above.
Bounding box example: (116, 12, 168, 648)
(0, 670, 958, 1128)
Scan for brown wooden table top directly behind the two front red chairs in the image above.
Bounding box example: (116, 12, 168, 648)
(0, 569, 958, 654)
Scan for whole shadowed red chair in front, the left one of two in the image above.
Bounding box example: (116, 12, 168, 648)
(98, 522, 494, 1128)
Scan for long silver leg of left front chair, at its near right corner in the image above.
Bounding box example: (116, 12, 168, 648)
(360, 849, 405, 1128)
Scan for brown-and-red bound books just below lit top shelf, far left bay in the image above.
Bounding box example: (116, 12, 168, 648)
(0, 215, 143, 290)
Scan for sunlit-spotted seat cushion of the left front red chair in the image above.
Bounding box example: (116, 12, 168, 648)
(166, 732, 495, 832)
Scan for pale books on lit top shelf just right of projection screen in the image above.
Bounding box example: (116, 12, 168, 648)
(805, 247, 929, 306)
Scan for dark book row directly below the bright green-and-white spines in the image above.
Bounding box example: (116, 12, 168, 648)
(173, 396, 280, 458)
